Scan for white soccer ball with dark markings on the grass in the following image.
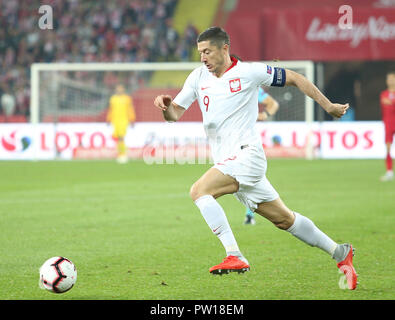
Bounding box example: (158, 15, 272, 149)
(39, 257, 77, 293)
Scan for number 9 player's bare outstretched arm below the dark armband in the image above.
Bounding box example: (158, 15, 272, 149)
(285, 69, 349, 118)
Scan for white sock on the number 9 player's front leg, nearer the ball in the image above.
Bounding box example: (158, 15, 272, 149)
(195, 195, 243, 257)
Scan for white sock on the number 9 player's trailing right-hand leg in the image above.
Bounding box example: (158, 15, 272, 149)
(287, 212, 337, 258)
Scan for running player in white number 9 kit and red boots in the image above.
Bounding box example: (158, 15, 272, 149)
(154, 27, 357, 289)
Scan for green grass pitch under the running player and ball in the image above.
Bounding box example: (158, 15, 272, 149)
(0, 159, 395, 300)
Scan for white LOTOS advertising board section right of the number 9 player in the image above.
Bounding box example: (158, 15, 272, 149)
(257, 121, 385, 159)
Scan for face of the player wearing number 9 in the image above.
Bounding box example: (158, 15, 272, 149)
(197, 41, 227, 74)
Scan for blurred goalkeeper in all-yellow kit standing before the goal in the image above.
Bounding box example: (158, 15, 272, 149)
(107, 84, 136, 163)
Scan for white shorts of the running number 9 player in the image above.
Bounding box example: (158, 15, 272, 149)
(214, 145, 279, 211)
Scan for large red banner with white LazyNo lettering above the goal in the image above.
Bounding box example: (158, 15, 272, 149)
(225, 0, 395, 61)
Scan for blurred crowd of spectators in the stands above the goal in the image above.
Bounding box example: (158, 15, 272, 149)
(0, 0, 198, 121)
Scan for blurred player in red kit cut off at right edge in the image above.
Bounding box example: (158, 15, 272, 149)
(380, 71, 395, 181)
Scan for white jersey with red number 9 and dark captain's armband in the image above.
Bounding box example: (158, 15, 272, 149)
(174, 58, 285, 163)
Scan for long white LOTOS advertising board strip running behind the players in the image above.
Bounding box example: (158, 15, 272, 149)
(0, 121, 395, 163)
